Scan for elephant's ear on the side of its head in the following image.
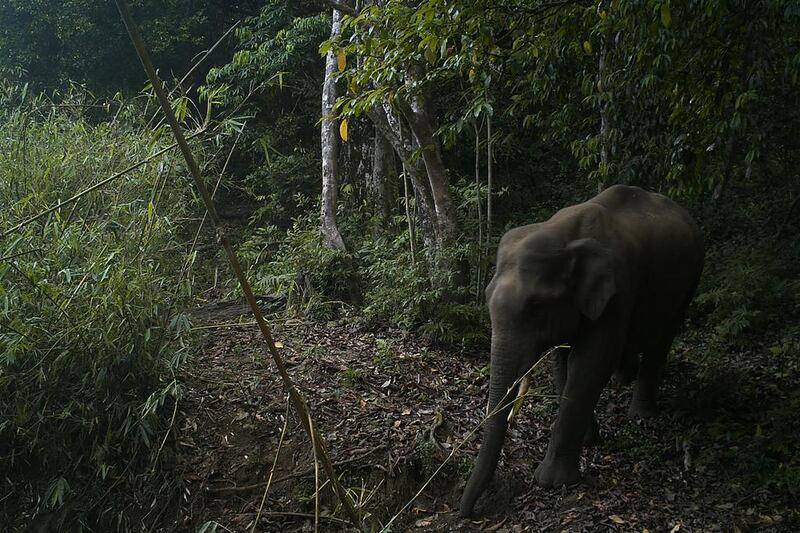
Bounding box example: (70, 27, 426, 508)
(567, 239, 617, 320)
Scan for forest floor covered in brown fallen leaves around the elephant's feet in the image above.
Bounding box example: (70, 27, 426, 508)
(164, 306, 800, 532)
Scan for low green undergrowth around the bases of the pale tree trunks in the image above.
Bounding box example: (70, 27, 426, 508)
(239, 204, 487, 345)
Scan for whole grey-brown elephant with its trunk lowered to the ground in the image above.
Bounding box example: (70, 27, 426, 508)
(460, 185, 703, 516)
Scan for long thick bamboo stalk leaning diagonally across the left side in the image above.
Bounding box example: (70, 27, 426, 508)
(114, 0, 361, 527)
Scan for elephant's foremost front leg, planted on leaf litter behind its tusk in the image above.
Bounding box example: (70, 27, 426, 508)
(534, 337, 620, 487)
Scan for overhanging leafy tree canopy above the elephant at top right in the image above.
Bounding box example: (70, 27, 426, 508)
(334, 0, 800, 193)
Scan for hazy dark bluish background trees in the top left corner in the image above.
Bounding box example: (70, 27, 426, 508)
(0, 0, 261, 94)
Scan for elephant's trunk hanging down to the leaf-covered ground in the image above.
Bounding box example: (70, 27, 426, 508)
(460, 334, 529, 517)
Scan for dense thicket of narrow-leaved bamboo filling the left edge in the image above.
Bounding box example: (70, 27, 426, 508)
(0, 82, 195, 527)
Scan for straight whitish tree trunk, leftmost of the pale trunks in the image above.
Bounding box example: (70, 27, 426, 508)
(320, 9, 345, 250)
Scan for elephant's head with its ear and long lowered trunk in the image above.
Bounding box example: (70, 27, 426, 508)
(460, 232, 616, 516)
